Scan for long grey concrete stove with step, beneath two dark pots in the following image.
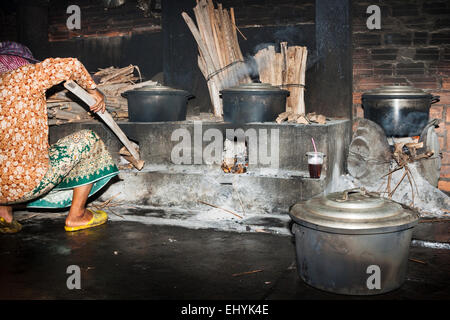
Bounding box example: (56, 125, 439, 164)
(50, 120, 351, 226)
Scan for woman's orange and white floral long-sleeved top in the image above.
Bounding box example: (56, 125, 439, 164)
(0, 58, 95, 204)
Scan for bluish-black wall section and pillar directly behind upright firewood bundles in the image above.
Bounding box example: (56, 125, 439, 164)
(162, 0, 352, 118)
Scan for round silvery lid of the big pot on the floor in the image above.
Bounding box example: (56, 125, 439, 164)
(289, 188, 419, 234)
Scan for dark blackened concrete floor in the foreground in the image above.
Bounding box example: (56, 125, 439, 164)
(0, 215, 450, 300)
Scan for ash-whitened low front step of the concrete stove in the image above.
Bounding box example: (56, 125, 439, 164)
(99, 166, 326, 214)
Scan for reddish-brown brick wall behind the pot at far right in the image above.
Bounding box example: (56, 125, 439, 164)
(352, 0, 450, 192)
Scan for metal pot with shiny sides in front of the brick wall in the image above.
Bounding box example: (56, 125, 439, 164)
(362, 86, 439, 137)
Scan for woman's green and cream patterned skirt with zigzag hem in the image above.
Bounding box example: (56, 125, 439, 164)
(16, 130, 119, 208)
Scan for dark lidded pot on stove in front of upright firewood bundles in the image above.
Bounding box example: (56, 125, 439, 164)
(220, 83, 289, 123)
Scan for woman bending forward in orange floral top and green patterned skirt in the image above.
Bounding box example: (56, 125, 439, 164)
(0, 44, 118, 233)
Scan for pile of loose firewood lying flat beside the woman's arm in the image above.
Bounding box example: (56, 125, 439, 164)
(47, 65, 157, 125)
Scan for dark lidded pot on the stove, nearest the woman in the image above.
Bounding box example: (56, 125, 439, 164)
(122, 85, 192, 122)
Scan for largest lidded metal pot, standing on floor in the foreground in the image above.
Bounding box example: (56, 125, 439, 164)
(289, 189, 419, 295)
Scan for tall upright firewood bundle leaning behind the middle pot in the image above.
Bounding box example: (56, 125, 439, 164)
(182, 0, 251, 117)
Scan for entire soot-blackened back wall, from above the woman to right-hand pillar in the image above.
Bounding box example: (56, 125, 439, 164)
(1, 0, 352, 118)
